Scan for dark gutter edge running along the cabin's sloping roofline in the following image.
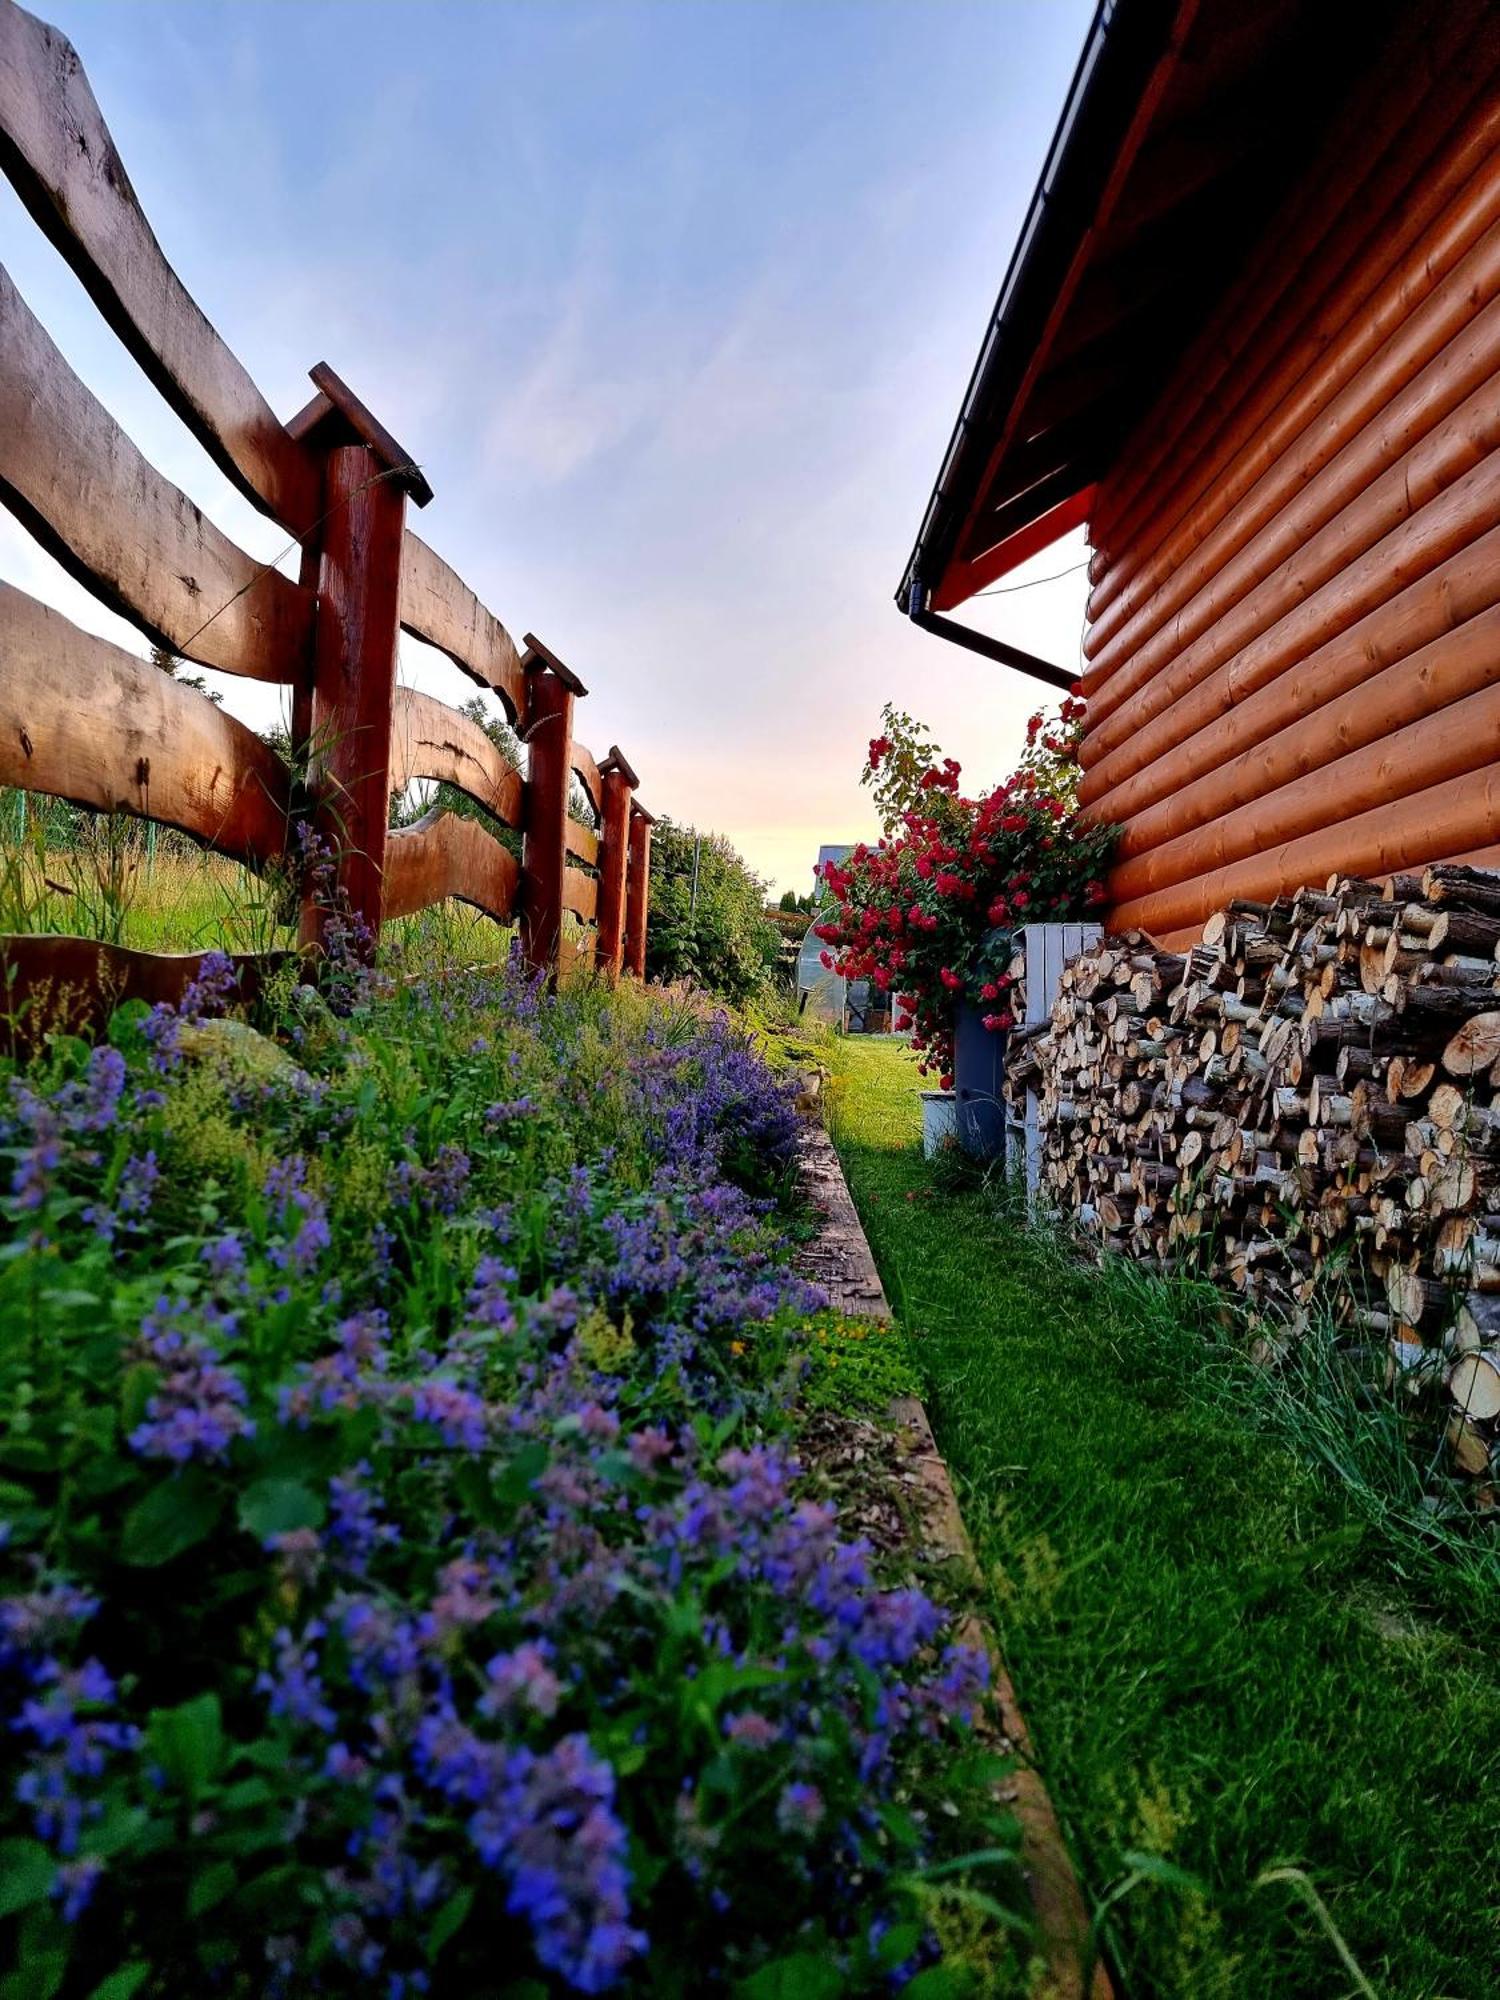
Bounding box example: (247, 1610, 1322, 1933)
(896, 0, 1176, 610)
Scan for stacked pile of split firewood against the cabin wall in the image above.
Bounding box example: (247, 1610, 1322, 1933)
(1010, 866, 1500, 1476)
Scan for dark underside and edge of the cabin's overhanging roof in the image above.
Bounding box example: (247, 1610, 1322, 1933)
(898, 0, 1398, 612)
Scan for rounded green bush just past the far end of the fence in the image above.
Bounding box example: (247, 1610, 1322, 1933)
(646, 820, 780, 1002)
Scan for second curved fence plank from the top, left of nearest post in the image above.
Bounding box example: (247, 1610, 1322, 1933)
(0, 268, 314, 680)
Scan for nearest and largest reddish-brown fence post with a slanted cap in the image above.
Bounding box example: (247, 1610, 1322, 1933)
(288, 362, 432, 954)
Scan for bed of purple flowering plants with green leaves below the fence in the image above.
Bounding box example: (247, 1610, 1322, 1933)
(0, 964, 1024, 2000)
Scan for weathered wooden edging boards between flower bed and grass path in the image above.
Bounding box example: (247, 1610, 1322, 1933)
(798, 1118, 1114, 2000)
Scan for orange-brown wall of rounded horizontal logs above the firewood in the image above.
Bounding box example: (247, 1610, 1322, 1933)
(1082, 8, 1500, 944)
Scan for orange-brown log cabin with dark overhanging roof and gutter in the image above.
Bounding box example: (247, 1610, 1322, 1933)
(898, 0, 1500, 946)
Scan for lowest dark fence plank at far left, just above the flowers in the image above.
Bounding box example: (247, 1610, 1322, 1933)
(0, 934, 296, 1054)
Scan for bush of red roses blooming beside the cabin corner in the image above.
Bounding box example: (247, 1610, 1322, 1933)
(814, 700, 1114, 1090)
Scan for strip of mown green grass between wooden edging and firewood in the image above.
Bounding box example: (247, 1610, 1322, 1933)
(832, 1042, 1500, 2000)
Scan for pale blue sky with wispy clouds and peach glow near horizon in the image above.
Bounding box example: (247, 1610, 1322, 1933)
(0, 0, 1092, 892)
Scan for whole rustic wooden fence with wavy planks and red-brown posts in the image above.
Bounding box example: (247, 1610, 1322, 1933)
(0, 0, 652, 1010)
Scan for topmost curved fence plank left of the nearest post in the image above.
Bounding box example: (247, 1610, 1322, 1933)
(0, 0, 320, 534)
